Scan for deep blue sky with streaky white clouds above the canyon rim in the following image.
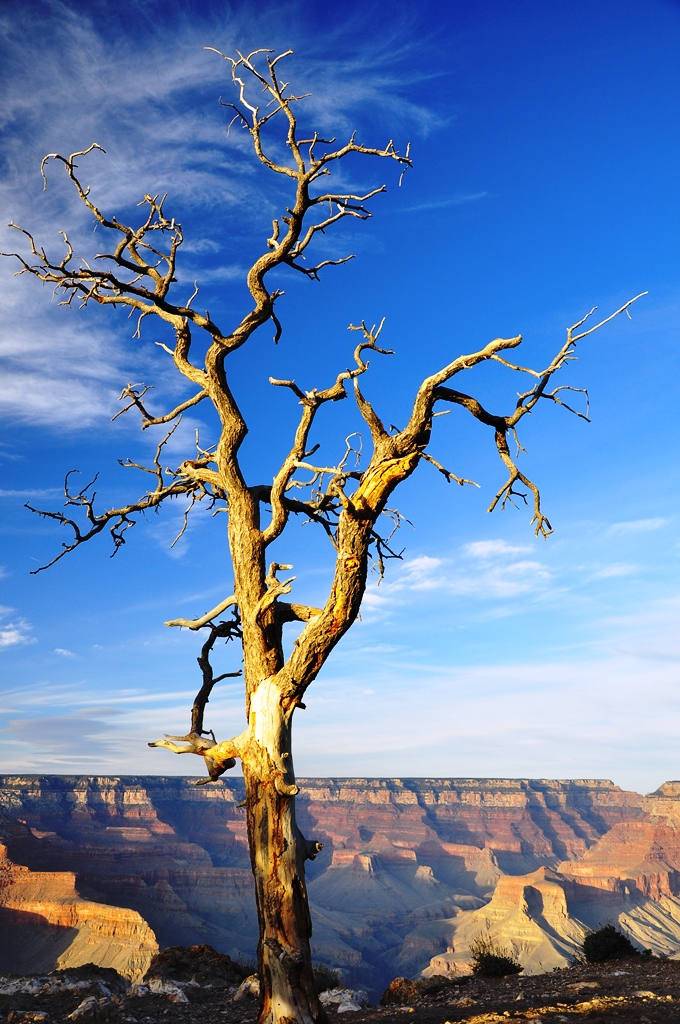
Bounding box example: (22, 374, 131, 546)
(0, 0, 680, 791)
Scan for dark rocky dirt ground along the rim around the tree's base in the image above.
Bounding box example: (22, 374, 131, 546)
(0, 956, 680, 1024)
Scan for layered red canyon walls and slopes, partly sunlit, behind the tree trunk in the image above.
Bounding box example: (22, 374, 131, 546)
(0, 775, 680, 991)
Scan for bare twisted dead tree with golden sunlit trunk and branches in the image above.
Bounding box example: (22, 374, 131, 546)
(3, 50, 639, 1024)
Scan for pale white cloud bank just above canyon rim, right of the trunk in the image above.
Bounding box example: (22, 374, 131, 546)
(296, 655, 680, 792)
